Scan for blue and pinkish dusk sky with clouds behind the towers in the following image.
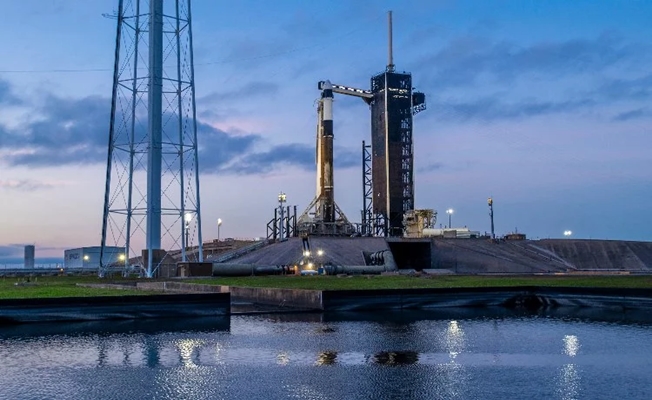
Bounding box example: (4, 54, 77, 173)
(0, 0, 652, 264)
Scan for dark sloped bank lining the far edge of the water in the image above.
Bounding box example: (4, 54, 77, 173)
(0, 282, 652, 326)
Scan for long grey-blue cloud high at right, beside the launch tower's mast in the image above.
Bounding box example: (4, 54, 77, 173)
(413, 34, 645, 88)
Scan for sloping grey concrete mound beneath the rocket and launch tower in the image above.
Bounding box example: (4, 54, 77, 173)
(218, 237, 652, 274)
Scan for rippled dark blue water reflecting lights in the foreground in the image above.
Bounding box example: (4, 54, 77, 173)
(0, 310, 652, 399)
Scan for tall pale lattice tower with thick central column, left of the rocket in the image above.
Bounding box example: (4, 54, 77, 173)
(100, 0, 203, 277)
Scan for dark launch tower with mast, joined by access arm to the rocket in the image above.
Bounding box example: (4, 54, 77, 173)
(276, 11, 428, 237)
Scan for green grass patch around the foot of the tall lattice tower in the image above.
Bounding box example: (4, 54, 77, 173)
(0, 276, 152, 299)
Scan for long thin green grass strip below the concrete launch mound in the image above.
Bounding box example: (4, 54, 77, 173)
(186, 275, 652, 290)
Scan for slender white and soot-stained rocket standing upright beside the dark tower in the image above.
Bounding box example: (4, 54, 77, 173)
(317, 81, 335, 222)
